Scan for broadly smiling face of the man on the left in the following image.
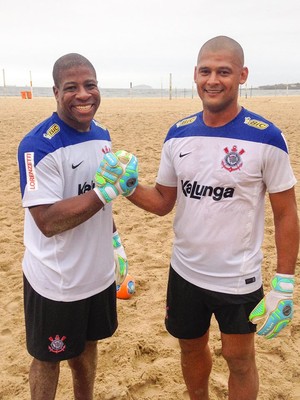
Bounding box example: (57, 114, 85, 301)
(53, 65, 101, 132)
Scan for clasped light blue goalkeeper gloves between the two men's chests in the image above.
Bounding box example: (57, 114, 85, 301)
(94, 150, 138, 204)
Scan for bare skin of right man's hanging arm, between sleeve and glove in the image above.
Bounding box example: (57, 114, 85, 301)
(269, 188, 299, 274)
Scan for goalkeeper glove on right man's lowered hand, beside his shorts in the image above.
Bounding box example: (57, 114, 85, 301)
(249, 274, 295, 339)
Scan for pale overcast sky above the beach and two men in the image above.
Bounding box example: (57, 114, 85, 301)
(0, 0, 300, 88)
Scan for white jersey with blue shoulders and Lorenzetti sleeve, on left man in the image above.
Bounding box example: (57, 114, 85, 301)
(18, 113, 114, 301)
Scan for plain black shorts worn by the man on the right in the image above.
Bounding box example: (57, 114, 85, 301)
(165, 267, 263, 339)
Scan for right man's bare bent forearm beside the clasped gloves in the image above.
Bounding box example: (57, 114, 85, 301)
(127, 183, 177, 216)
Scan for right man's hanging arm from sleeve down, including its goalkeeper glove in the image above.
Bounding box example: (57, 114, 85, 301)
(249, 188, 299, 339)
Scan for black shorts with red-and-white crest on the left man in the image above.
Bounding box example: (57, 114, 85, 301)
(23, 276, 118, 362)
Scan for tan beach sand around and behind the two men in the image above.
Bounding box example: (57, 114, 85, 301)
(0, 96, 300, 400)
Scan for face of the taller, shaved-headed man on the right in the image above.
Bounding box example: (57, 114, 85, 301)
(194, 50, 248, 113)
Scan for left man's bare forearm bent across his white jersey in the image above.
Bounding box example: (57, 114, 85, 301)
(30, 190, 103, 237)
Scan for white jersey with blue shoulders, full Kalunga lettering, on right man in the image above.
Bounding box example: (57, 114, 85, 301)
(157, 108, 296, 294)
